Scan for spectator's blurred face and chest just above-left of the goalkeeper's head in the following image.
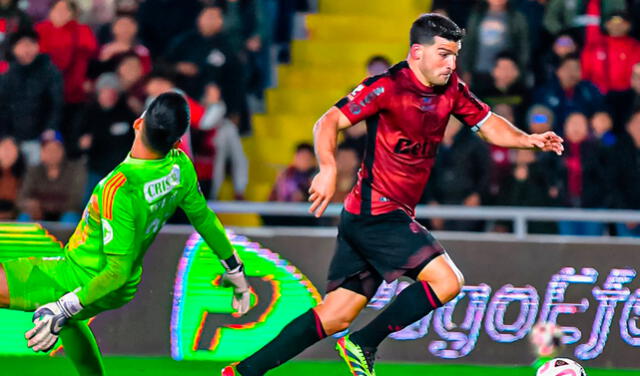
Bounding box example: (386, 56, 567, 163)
(116, 52, 147, 114)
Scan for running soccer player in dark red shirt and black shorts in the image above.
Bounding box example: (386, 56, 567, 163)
(222, 14, 563, 376)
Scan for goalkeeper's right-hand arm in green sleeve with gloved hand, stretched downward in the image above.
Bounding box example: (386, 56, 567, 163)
(180, 164, 251, 315)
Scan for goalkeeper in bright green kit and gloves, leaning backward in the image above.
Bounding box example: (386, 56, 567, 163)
(0, 92, 250, 375)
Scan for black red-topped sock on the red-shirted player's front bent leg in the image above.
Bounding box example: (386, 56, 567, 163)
(349, 281, 442, 351)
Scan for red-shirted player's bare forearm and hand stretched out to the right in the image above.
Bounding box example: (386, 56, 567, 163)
(476, 113, 564, 155)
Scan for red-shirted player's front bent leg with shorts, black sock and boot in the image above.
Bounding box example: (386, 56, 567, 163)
(337, 211, 463, 374)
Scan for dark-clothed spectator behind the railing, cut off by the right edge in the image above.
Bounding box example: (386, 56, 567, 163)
(607, 111, 640, 237)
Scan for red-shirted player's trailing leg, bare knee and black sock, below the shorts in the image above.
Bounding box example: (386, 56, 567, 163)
(232, 288, 368, 376)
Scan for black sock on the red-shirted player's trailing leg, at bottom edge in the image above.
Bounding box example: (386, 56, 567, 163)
(236, 309, 327, 376)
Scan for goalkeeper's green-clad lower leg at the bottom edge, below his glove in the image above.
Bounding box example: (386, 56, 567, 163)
(60, 321, 105, 376)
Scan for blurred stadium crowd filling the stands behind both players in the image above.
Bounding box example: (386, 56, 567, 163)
(0, 0, 640, 236)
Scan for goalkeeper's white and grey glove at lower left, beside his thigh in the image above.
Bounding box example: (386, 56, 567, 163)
(25, 292, 82, 352)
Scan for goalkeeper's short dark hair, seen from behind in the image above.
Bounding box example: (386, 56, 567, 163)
(142, 92, 190, 155)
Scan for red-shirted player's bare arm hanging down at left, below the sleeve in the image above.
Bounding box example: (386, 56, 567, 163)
(309, 107, 352, 217)
